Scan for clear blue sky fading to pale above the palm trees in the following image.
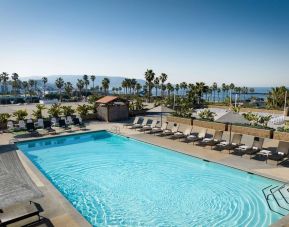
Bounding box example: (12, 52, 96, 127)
(0, 0, 289, 86)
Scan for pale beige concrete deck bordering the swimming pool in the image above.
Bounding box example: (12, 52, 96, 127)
(0, 122, 289, 227)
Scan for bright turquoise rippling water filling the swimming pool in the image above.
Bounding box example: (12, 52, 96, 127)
(18, 131, 281, 227)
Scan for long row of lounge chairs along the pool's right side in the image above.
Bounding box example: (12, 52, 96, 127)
(124, 117, 289, 164)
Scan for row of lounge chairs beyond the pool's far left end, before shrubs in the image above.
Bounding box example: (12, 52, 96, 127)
(7, 116, 86, 136)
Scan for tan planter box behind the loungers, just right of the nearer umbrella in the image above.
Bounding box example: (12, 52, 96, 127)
(228, 125, 273, 139)
